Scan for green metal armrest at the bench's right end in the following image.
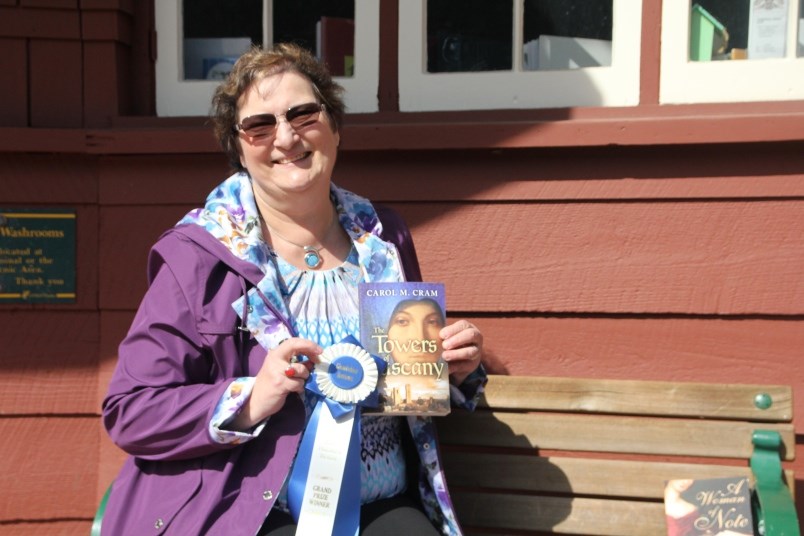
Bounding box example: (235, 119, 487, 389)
(750, 430, 801, 536)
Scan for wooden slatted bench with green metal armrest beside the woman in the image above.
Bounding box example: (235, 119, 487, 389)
(437, 376, 800, 536)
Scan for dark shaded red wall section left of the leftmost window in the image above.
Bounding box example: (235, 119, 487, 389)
(0, 0, 137, 128)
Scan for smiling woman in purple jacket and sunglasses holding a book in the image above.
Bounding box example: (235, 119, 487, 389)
(102, 45, 485, 536)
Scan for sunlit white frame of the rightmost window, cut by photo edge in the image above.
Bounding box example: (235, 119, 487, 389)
(659, 0, 804, 104)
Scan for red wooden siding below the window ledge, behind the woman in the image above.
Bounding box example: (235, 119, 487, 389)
(0, 142, 804, 533)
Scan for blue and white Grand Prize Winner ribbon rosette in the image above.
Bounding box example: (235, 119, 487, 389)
(288, 336, 387, 536)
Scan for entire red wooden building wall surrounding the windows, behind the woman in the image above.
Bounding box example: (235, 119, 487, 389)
(0, 0, 804, 536)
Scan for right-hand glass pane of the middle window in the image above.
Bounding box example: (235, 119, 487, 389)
(522, 0, 612, 71)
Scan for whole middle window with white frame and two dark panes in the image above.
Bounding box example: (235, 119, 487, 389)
(399, 0, 642, 111)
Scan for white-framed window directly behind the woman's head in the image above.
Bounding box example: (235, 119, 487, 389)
(154, 0, 379, 117)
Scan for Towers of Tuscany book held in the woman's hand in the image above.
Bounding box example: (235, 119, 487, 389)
(358, 282, 450, 415)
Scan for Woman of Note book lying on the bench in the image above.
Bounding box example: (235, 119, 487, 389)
(664, 476, 754, 536)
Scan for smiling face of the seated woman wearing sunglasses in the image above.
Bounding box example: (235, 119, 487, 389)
(237, 71, 340, 203)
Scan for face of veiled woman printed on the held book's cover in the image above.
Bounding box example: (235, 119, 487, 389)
(388, 303, 444, 363)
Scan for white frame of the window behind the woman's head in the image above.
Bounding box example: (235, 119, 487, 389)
(154, 0, 380, 117)
